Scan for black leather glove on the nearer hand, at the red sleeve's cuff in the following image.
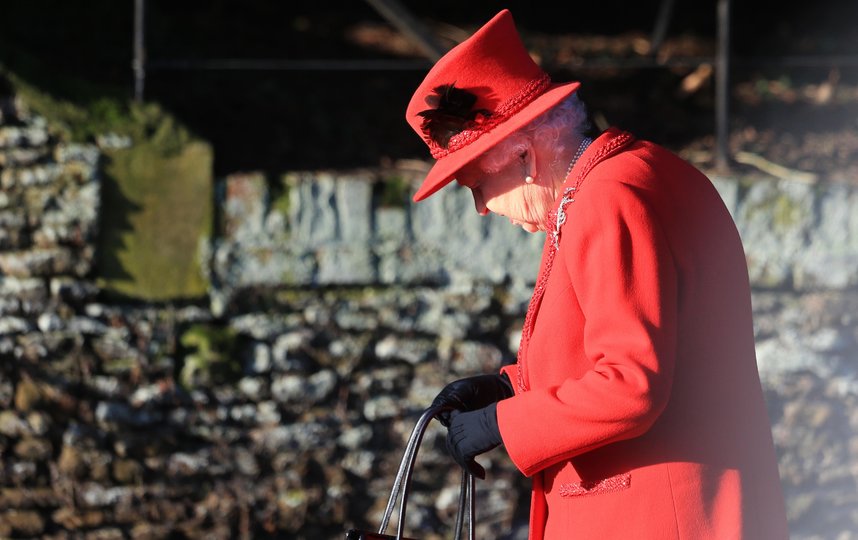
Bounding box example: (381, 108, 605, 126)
(447, 403, 503, 479)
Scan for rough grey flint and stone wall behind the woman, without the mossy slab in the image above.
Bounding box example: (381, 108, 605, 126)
(0, 90, 858, 540)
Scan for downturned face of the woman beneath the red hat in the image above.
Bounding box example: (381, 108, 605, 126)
(456, 148, 555, 233)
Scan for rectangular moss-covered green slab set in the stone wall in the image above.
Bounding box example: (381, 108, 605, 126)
(98, 141, 213, 301)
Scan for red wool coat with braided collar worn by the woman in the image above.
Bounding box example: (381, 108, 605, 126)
(497, 129, 788, 540)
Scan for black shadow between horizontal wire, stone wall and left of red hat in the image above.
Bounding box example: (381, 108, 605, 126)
(149, 71, 432, 176)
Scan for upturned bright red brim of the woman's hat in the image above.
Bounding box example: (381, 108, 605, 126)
(413, 81, 581, 202)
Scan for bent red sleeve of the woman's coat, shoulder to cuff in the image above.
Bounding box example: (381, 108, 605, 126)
(498, 170, 678, 476)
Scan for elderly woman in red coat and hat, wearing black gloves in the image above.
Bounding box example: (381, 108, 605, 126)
(407, 10, 788, 540)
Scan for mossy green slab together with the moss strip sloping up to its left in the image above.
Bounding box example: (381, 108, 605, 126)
(7, 68, 214, 301)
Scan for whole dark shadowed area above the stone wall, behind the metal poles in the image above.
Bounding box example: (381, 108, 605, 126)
(0, 0, 858, 175)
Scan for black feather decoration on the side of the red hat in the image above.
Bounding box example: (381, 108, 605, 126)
(417, 83, 492, 148)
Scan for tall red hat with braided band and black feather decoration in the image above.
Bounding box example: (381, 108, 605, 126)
(405, 9, 580, 202)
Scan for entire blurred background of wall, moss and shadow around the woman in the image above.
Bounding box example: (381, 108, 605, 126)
(0, 0, 858, 540)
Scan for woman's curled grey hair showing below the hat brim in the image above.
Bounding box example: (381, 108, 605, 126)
(477, 94, 590, 173)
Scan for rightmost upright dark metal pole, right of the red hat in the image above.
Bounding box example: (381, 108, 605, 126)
(715, 0, 730, 171)
